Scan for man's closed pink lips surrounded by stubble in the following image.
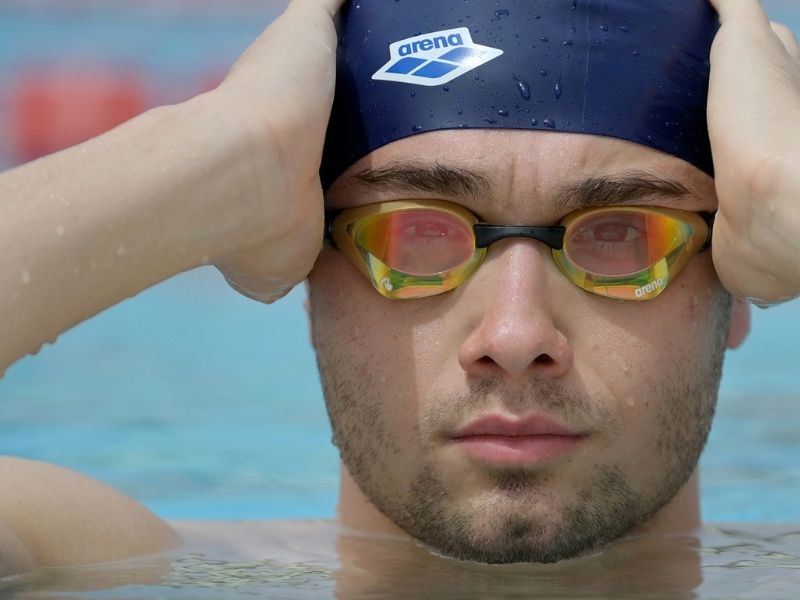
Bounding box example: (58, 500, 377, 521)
(449, 414, 587, 466)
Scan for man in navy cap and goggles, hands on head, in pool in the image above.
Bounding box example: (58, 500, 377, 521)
(0, 0, 800, 575)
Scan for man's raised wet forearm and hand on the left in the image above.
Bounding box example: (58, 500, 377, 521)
(0, 0, 343, 376)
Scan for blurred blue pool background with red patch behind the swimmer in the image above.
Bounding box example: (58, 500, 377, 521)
(0, 0, 800, 522)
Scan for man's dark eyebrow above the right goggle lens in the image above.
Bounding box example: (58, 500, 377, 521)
(555, 171, 691, 213)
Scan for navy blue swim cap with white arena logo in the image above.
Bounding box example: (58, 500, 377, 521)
(321, 0, 719, 189)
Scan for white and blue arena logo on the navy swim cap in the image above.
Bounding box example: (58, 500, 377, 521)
(372, 27, 503, 87)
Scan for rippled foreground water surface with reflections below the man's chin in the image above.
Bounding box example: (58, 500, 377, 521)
(0, 521, 800, 600)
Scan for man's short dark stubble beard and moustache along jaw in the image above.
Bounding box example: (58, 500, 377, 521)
(315, 296, 730, 563)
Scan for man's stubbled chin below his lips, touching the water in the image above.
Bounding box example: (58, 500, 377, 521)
(390, 468, 646, 564)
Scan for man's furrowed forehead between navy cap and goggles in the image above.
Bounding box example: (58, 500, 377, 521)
(329, 130, 713, 216)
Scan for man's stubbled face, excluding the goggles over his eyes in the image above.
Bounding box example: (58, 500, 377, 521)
(310, 131, 730, 562)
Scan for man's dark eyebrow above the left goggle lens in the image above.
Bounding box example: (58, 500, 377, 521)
(352, 163, 491, 199)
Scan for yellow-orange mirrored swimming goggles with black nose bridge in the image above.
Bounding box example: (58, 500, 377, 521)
(326, 200, 714, 300)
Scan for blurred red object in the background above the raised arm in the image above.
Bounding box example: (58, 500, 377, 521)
(11, 68, 146, 162)
